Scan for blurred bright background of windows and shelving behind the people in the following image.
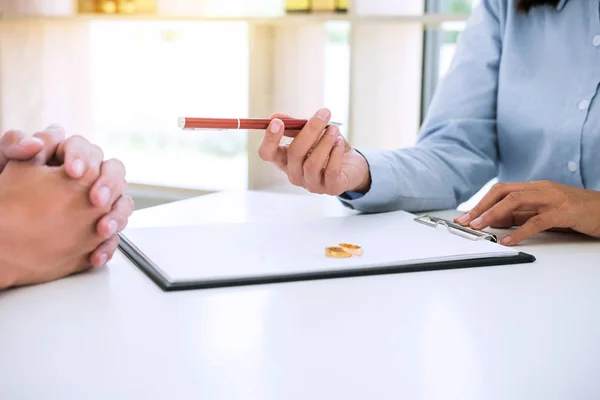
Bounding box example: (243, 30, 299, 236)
(0, 0, 477, 208)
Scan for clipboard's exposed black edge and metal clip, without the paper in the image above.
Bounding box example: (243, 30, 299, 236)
(119, 215, 536, 292)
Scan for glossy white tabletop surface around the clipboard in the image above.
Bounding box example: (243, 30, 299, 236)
(0, 193, 600, 400)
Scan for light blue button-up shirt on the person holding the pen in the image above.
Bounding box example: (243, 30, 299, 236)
(339, 0, 600, 212)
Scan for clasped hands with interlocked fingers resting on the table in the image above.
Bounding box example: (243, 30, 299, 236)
(0, 125, 134, 289)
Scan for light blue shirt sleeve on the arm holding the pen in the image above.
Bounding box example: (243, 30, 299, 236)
(339, 0, 507, 212)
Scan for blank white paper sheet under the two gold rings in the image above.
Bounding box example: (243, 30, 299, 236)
(119, 211, 518, 282)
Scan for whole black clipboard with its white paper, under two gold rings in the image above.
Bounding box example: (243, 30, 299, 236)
(119, 211, 535, 292)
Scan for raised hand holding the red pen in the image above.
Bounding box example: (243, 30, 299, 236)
(258, 108, 371, 196)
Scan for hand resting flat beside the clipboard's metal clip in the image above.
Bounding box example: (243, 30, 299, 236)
(455, 181, 600, 246)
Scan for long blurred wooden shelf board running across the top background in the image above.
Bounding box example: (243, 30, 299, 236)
(0, 13, 469, 27)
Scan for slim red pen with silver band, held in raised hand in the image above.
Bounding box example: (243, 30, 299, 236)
(177, 117, 342, 130)
